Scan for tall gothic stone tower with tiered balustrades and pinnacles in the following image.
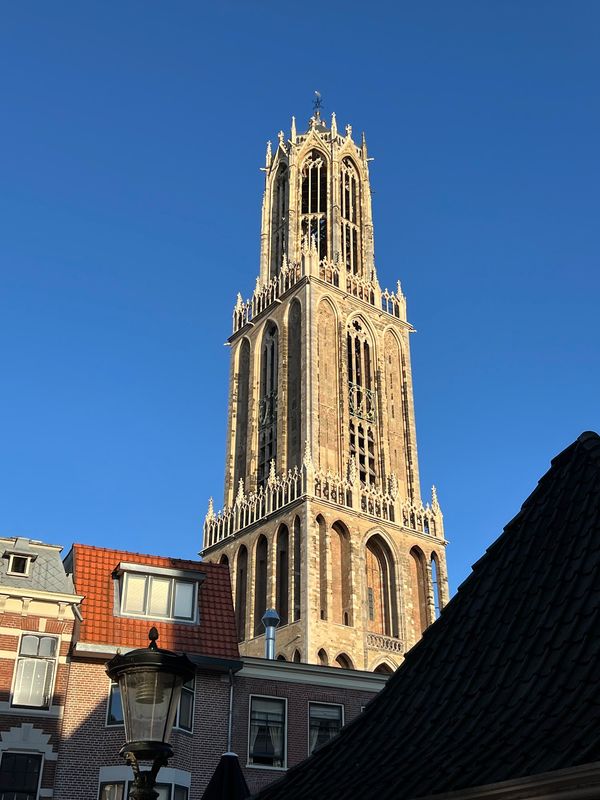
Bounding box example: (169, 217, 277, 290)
(203, 110, 448, 671)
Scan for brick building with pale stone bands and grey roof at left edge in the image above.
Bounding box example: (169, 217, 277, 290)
(0, 538, 81, 800)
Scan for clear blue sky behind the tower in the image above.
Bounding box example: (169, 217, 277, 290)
(0, 0, 600, 588)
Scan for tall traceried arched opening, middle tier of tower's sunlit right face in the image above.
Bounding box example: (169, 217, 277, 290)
(346, 319, 378, 485)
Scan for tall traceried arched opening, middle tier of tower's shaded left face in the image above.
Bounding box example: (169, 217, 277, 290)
(258, 322, 279, 486)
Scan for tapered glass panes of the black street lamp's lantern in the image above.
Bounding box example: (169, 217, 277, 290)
(119, 669, 182, 743)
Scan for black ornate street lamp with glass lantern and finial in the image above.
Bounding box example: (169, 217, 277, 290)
(106, 628, 195, 800)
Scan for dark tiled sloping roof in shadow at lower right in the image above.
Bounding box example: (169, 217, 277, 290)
(258, 433, 600, 800)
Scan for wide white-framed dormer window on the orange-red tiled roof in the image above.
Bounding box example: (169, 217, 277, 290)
(117, 564, 204, 622)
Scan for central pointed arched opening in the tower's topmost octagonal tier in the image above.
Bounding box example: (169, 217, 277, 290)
(300, 150, 328, 259)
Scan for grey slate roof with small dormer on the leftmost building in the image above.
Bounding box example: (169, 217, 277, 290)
(0, 537, 75, 594)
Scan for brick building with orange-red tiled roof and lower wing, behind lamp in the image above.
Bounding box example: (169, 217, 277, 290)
(50, 545, 386, 800)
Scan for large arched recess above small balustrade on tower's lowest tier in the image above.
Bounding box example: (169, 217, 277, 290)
(365, 534, 399, 636)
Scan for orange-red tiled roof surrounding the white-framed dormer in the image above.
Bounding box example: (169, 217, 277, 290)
(72, 544, 239, 659)
